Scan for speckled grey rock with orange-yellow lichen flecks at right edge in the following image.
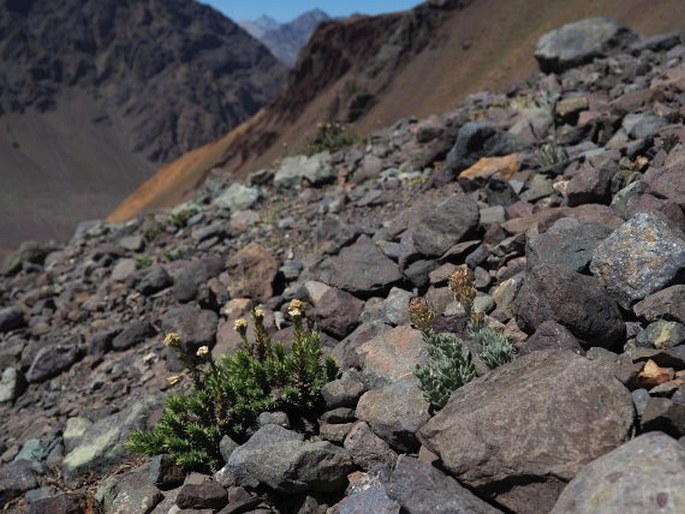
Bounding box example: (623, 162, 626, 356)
(590, 212, 685, 309)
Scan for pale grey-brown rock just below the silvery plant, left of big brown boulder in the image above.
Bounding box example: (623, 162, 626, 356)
(357, 377, 430, 453)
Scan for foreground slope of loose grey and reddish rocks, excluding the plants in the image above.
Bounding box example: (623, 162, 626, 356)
(0, 18, 685, 513)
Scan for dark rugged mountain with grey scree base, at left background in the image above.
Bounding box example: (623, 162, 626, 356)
(0, 0, 286, 254)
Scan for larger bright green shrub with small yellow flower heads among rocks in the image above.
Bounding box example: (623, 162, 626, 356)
(126, 300, 337, 470)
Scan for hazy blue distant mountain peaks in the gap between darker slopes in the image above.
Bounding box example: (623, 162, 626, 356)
(241, 9, 331, 68)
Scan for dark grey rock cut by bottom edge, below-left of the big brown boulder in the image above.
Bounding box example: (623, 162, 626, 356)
(386, 455, 501, 514)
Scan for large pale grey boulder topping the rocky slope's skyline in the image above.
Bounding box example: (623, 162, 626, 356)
(535, 17, 637, 73)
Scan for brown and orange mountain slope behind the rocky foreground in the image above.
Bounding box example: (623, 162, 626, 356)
(110, 0, 685, 221)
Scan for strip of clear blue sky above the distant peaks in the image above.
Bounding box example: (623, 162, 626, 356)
(200, 0, 421, 22)
